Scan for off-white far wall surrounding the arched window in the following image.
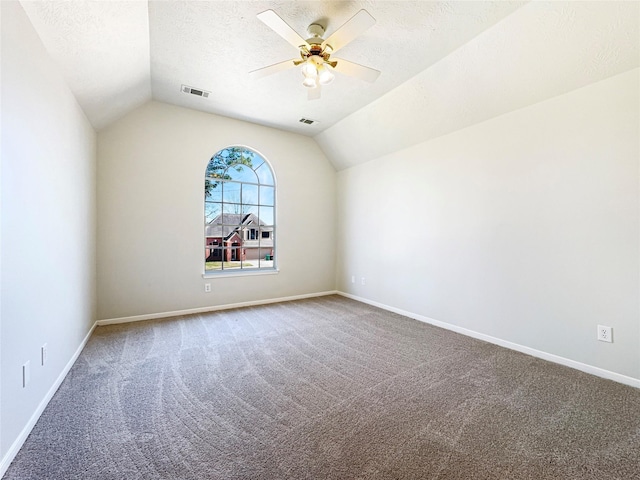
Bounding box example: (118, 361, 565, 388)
(98, 100, 335, 319)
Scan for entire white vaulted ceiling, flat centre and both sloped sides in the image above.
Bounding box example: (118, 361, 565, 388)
(21, 0, 640, 168)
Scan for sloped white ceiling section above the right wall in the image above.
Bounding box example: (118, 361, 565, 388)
(315, 2, 640, 170)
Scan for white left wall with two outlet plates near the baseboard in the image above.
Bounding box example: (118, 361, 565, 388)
(0, 2, 96, 474)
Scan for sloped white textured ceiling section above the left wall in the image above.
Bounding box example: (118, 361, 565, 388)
(21, 1, 151, 129)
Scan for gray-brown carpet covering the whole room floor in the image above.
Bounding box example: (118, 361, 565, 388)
(5, 296, 640, 480)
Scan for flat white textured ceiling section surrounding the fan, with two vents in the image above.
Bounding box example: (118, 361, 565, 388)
(149, 1, 521, 135)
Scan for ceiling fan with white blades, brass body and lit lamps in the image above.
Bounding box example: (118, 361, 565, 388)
(249, 10, 380, 100)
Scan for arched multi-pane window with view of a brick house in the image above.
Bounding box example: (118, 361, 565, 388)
(204, 146, 276, 274)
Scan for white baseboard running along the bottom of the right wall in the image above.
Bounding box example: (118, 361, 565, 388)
(338, 292, 640, 388)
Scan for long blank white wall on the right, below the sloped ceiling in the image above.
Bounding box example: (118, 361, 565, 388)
(337, 69, 640, 379)
